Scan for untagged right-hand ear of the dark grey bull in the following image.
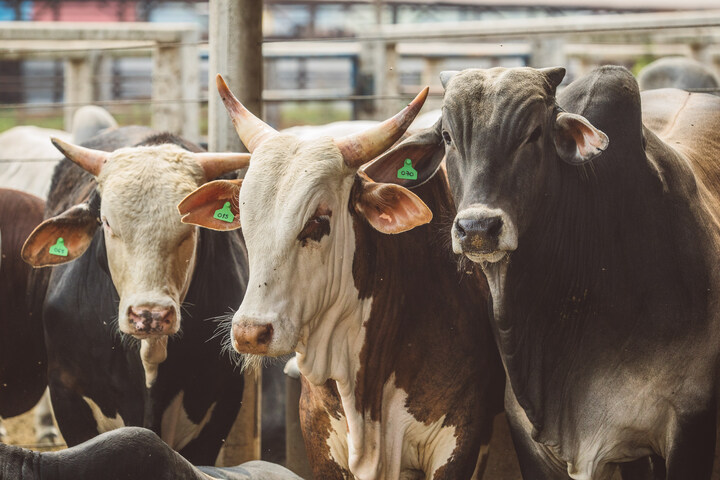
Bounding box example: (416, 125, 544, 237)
(554, 112, 610, 165)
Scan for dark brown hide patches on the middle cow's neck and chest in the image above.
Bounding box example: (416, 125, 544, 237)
(301, 172, 504, 479)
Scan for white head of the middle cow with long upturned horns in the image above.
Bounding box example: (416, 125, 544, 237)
(178, 77, 432, 368)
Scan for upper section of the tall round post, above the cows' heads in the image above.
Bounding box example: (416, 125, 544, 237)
(208, 0, 263, 152)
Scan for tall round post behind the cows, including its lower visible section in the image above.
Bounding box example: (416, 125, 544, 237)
(208, 0, 263, 465)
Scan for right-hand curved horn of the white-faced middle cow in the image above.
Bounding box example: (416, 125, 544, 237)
(335, 87, 429, 168)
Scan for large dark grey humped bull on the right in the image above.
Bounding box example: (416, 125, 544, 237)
(376, 66, 720, 480)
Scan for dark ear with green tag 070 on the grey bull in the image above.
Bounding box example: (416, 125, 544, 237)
(361, 119, 445, 189)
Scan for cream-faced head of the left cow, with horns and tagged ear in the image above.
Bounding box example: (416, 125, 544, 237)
(22, 139, 249, 339)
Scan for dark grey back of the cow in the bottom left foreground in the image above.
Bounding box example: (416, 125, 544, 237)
(0, 427, 302, 480)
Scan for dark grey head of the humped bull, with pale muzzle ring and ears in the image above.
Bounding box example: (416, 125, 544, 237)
(376, 68, 608, 263)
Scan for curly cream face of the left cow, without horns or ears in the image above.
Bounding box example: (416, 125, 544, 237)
(97, 145, 205, 338)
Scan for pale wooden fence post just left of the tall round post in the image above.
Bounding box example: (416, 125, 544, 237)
(152, 28, 200, 141)
